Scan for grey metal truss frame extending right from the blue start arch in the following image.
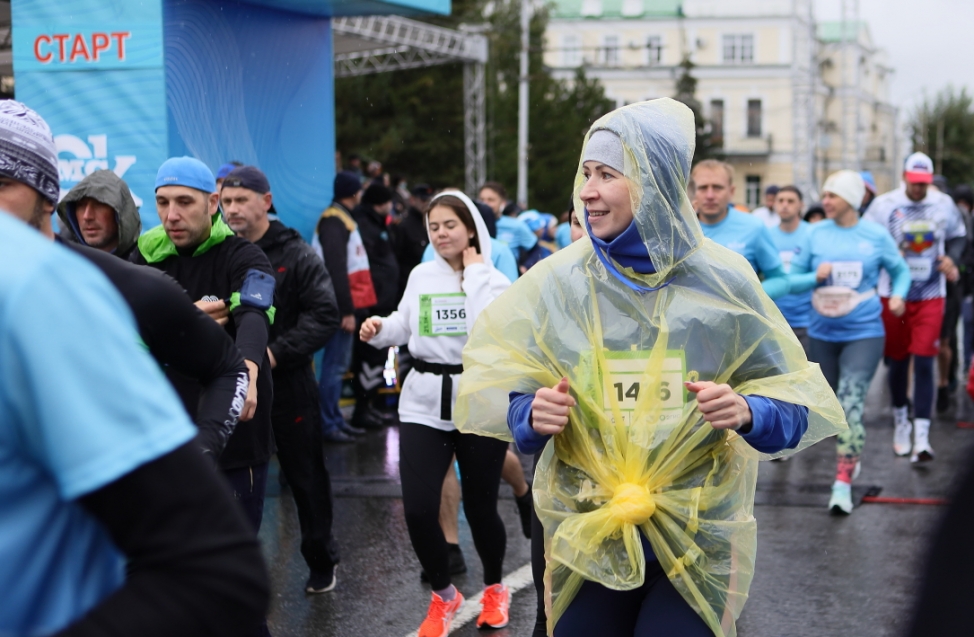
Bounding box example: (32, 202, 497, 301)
(331, 16, 487, 194)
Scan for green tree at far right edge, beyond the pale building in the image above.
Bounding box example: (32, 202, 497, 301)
(910, 86, 974, 186)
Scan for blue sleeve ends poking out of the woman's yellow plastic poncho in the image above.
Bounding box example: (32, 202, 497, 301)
(507, 392, 808, 454)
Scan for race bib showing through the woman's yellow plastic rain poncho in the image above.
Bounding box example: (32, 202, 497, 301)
(602, 351, 686, 426)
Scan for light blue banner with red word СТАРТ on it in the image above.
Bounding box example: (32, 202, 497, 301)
(11, 0, 168, 228)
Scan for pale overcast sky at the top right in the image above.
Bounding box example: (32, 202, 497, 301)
(814, 0, 974, 113)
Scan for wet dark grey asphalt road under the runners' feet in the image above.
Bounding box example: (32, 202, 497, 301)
(260, 365, 974, 637)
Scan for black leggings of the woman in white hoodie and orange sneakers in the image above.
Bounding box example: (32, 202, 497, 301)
(399, 422, 507, 590)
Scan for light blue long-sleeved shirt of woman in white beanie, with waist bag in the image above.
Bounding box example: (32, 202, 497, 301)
(791, 219, 910, 343)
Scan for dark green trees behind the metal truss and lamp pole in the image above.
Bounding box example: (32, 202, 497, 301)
(335, 0, 614, 214)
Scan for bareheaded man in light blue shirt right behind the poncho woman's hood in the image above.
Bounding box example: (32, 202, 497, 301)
(691, 159, 788, 299)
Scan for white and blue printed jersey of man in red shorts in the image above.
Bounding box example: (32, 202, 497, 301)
(863, 189, 967, 301)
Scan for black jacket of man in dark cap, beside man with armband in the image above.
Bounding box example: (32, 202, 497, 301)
(257, 220, 340, 375)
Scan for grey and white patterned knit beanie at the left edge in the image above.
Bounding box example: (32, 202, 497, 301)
(0, 100, 61, 206)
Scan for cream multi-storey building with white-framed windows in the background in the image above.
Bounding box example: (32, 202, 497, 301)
(544, 0, 899, 207)
